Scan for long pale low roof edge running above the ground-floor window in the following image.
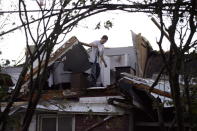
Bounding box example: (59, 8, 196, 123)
(9, 101, 125, 115)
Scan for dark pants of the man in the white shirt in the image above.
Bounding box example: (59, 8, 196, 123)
(90, 63, 101, 86)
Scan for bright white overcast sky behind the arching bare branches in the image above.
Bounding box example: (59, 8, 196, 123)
(0, 0, 171, 64)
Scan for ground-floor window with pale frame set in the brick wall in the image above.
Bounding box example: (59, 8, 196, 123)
(39, 115, 74, 131)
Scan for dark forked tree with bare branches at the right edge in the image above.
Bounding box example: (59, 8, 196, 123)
(150, 0, 197, 131)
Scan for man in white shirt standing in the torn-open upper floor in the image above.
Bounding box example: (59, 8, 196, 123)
(82, 35, 108, 86)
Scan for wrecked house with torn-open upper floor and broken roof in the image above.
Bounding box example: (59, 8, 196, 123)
(2, 33, 174, 131)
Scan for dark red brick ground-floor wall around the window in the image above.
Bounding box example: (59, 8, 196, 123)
(29, 114, 129, 131)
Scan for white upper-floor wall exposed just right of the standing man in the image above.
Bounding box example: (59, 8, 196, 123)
(98, 47, 136, 86)
